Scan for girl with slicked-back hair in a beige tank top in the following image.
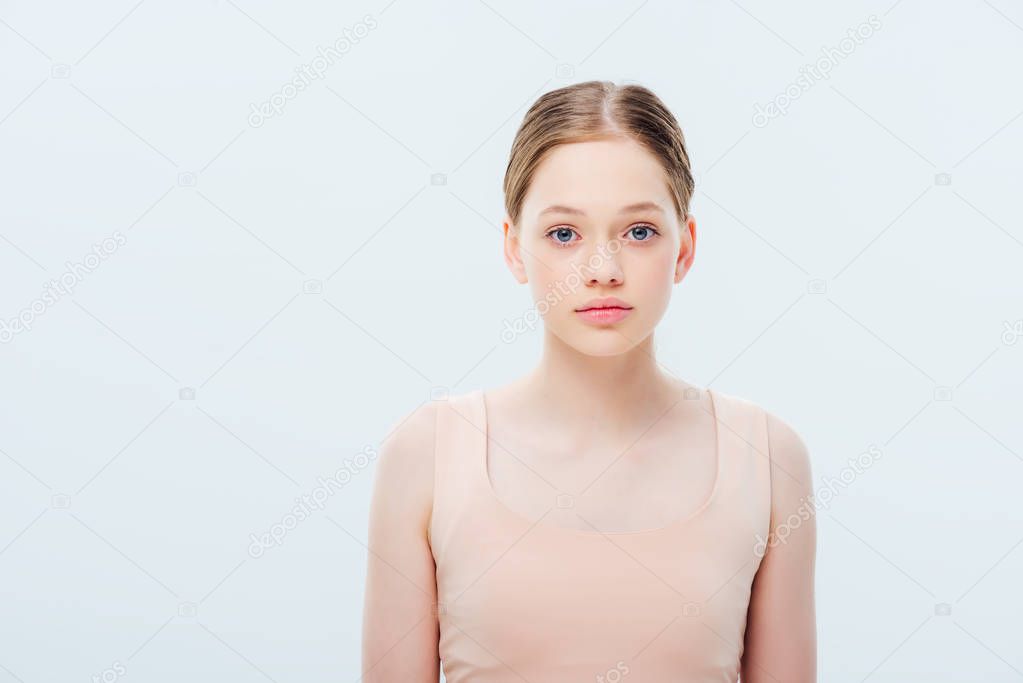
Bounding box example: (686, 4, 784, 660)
(362, 81, 816, 683)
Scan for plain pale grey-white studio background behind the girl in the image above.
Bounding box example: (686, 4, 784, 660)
(0, 0, 1023, 683)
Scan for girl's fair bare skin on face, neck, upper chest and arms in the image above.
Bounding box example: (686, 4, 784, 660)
(362, 137, 816, 683)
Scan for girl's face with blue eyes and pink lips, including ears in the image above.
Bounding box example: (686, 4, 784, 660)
(504, 138, 696, 356)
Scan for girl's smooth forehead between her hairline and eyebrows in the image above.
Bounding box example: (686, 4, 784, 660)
(523, 138, 672, 220)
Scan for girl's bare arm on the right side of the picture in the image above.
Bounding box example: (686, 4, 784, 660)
(741, 413, 817, 683)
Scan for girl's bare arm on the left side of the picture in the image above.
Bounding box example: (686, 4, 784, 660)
(361, 402, 440, 683)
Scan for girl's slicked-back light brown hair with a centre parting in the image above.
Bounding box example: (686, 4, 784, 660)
(504, 81, 694, 226)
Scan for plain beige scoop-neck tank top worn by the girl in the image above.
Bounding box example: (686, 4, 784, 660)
(429, 390, 770, 683)
